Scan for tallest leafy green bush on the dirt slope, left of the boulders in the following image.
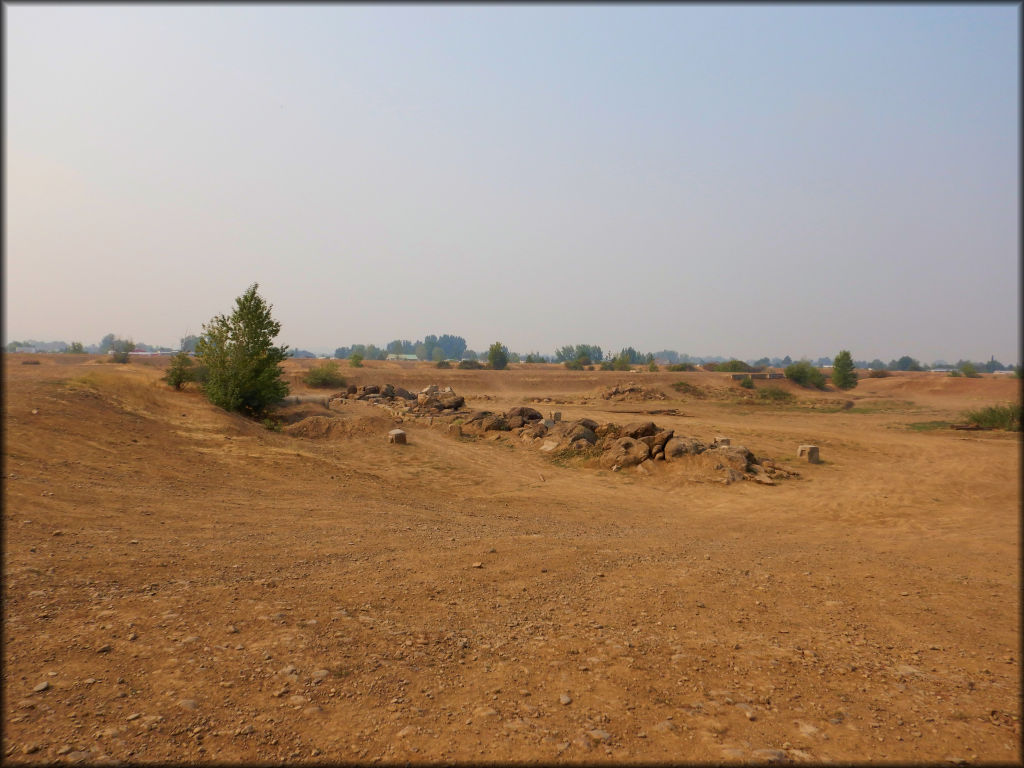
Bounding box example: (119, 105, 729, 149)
(197, 284, 288, 416)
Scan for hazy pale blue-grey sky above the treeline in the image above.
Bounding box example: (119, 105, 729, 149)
(3, 4, 1021, 362)
